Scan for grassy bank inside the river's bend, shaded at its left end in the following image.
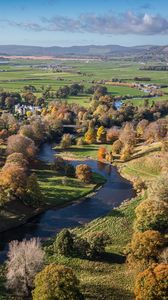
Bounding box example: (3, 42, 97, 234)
(0, 165, 106, 233)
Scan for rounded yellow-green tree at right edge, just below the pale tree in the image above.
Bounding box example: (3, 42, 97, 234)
(134, 200, 168, 232)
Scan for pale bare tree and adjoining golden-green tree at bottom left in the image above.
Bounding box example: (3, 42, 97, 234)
(6, 239, 84, 300)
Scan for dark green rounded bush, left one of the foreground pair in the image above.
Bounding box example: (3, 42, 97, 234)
(54, 229, 74, 256)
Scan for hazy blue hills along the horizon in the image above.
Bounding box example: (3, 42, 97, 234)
(0, 45, 168, 57)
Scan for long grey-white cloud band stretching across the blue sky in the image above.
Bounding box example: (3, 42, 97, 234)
(1, 11, 168, 35)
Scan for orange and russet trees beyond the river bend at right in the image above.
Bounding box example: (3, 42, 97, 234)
(96, 119, 168, 161)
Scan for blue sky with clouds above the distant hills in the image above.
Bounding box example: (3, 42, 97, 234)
(0, 0, 168, 47)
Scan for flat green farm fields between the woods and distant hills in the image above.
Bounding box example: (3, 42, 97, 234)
(0, 60, 168, 107)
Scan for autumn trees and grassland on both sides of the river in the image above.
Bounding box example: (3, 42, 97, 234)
(0, 57, 168, 300)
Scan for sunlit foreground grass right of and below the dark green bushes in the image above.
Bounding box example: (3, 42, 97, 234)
(48, 198, 142, 300)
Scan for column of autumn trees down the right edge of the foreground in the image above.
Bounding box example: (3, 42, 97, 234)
(127, 174, 168, 300)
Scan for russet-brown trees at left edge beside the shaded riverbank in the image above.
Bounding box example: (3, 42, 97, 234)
(0, 134, 43, 207)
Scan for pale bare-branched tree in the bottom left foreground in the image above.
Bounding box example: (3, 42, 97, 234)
(6, 238, 44, 296)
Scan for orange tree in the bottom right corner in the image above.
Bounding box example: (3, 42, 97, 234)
(134, 264, 168, 300)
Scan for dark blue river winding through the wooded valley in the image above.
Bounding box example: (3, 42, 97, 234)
(0, 143, 135, 261)
